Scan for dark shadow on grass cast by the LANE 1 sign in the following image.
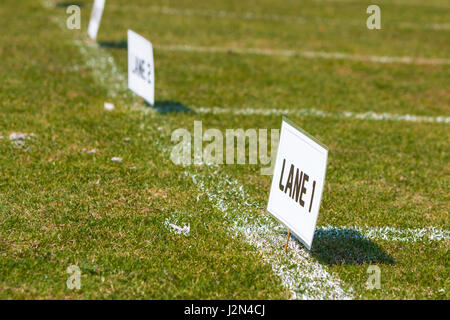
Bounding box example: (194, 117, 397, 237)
(296, 228, 395, 265)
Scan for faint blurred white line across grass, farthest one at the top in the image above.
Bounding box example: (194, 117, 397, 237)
(109, 5, 450, 30)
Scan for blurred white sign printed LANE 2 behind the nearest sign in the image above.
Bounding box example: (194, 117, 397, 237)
(128, 30, 155, 105)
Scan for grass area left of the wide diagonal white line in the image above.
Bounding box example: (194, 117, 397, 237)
(0, 1, 288, 299)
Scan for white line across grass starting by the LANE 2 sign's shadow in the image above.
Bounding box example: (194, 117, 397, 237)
(194, 107, 450, 123)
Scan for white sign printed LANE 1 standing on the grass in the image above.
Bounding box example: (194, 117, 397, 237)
(267, 118, 328, 249)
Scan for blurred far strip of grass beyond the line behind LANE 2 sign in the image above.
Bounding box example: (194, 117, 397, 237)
(102, 0, 449, 58)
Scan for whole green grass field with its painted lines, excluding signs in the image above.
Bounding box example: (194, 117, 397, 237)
(0, 0, 450, 299)
